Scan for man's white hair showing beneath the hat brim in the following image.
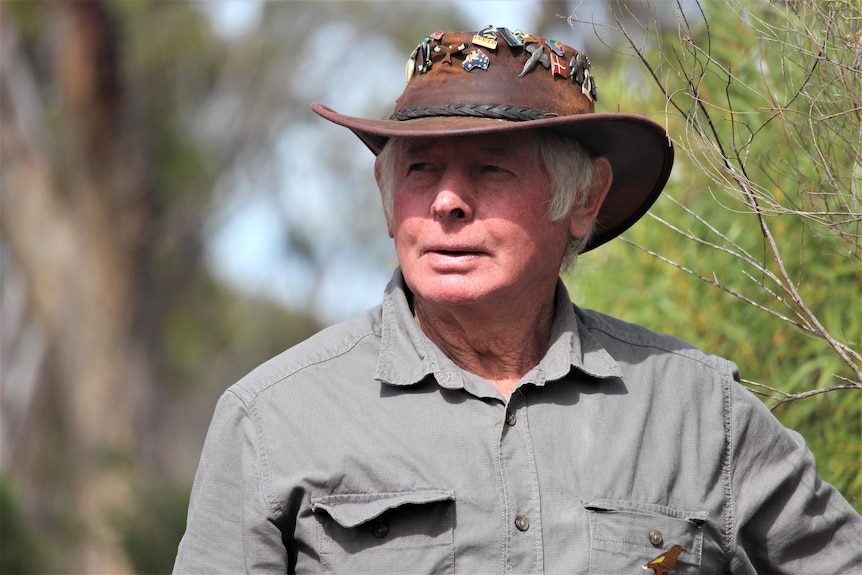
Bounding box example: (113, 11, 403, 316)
(375, 130, 593, 269)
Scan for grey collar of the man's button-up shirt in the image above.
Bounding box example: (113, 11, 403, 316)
(375, 269, 622, 389)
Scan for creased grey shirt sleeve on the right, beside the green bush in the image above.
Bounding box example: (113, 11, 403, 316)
(731, 385, 862, 574)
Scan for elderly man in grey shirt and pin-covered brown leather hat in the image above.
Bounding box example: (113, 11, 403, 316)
(175, 28, 862, 574)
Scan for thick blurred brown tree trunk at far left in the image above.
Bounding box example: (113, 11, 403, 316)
(0, 1, 153, 573)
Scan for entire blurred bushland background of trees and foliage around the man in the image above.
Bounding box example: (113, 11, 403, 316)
(0, 0, 862, 573)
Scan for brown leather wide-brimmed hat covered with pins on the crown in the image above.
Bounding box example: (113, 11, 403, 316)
(311, 26, 673, 251)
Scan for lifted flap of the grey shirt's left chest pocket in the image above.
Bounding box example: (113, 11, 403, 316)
(311, 489, 455, 529)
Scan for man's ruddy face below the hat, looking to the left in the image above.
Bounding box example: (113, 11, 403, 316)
(387, 132, 572, 316)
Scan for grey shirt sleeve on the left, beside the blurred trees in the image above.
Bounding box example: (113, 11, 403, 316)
(174, 390, 287, 573)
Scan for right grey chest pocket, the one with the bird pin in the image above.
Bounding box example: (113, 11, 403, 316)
(584, 500, 707, 575)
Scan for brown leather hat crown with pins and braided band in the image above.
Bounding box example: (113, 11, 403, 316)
(391, 26, 595, 121)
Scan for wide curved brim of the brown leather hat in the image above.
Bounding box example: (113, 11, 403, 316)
(311, 102, 673, 253)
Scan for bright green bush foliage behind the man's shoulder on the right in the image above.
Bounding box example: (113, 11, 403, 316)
(570, 2, 862, 510)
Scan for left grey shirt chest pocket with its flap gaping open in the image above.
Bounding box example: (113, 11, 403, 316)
(311, 490, 455, 573)
